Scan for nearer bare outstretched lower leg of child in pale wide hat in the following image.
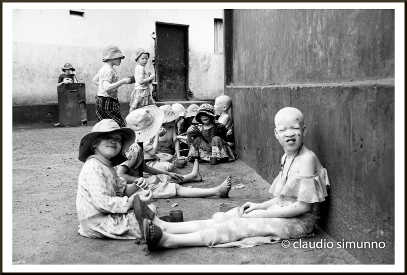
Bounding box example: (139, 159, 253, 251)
(176, 176, 232, 198)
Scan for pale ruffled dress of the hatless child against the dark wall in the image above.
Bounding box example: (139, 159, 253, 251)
(194, 168, 329, 247)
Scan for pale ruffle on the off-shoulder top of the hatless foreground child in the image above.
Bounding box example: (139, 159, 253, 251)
(269, 168, 329, 203)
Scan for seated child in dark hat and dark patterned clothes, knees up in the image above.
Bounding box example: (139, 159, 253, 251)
(187, 103, 235, 162)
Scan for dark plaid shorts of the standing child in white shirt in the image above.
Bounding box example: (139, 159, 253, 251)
(95, 96, 126, 127)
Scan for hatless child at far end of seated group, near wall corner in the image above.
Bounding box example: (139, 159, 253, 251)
(213, 95, 234, 147)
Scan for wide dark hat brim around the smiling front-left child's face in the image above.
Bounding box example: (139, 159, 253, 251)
(78, 128, 135, 166)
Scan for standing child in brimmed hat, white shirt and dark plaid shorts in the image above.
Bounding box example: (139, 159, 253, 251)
(93, 45, 131, 127)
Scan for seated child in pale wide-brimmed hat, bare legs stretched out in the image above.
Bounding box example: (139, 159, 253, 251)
(116, 106, 231, 199)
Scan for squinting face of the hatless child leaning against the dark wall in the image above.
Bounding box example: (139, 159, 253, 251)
(274, 113, 305, 152)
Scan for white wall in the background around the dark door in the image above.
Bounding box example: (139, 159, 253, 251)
(12, 9, 223, 105)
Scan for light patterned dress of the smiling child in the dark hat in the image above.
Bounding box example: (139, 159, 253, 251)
(76, 155, 141, 239)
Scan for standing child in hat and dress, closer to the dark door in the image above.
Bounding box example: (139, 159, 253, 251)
(130, 48, 155, 112)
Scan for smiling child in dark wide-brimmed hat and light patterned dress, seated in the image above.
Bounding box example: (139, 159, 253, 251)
(76, 119, 155, 239)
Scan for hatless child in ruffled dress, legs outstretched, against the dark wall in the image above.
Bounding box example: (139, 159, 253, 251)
(140, 107, 329, 251)
